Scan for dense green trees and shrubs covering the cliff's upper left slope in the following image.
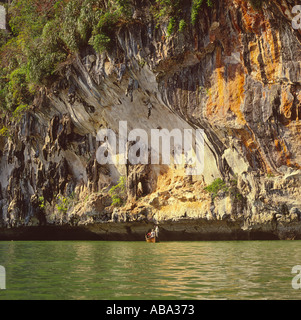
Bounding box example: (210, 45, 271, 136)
(0, 0, 213, 127)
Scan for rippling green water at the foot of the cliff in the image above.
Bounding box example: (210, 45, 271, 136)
(0, 241, 301, 300)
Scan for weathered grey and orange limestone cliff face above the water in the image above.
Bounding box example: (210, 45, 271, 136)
(0, 0, 301, 240)
